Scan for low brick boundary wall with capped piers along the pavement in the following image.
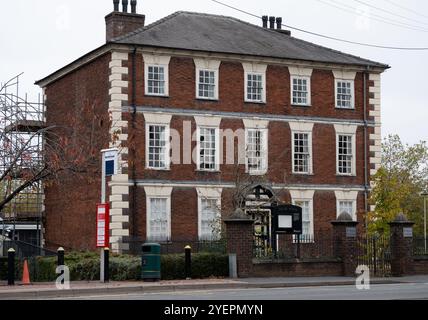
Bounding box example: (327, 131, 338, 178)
(225, 210, 428, 277)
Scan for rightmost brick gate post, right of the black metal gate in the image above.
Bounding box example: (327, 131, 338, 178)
(389, 213, 414, 277)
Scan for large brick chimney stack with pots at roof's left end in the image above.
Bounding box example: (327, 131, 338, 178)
(105, 0, 146, 42)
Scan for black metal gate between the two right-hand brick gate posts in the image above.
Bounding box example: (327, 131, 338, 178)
(357, 236, 391, 277)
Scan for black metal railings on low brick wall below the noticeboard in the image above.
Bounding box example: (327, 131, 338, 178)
(253, 235, 335, 260)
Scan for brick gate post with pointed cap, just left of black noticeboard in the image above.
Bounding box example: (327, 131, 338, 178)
(224, 209, 254, 277)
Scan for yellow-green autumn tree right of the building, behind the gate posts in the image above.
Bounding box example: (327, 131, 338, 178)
(368, 135, 428, 234)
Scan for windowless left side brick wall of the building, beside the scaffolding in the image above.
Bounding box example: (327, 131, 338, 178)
(44, 54, 111, 250)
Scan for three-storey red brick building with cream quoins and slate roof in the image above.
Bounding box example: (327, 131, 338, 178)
(38, 1, 388, 251)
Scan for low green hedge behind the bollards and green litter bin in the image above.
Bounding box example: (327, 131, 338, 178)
(0, 252, 229, 282)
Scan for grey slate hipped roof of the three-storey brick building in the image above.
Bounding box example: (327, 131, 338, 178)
(111, 11, 389, 69)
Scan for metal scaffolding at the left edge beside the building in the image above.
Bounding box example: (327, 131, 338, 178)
(0, 74, 45, 244)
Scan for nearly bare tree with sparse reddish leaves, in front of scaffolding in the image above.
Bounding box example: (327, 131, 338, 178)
(0, 76, 111, 216)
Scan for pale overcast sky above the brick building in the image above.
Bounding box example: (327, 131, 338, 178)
(0, 0, 428, 144)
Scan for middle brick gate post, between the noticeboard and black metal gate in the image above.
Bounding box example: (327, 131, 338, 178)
(331, 213, 358, 276)
